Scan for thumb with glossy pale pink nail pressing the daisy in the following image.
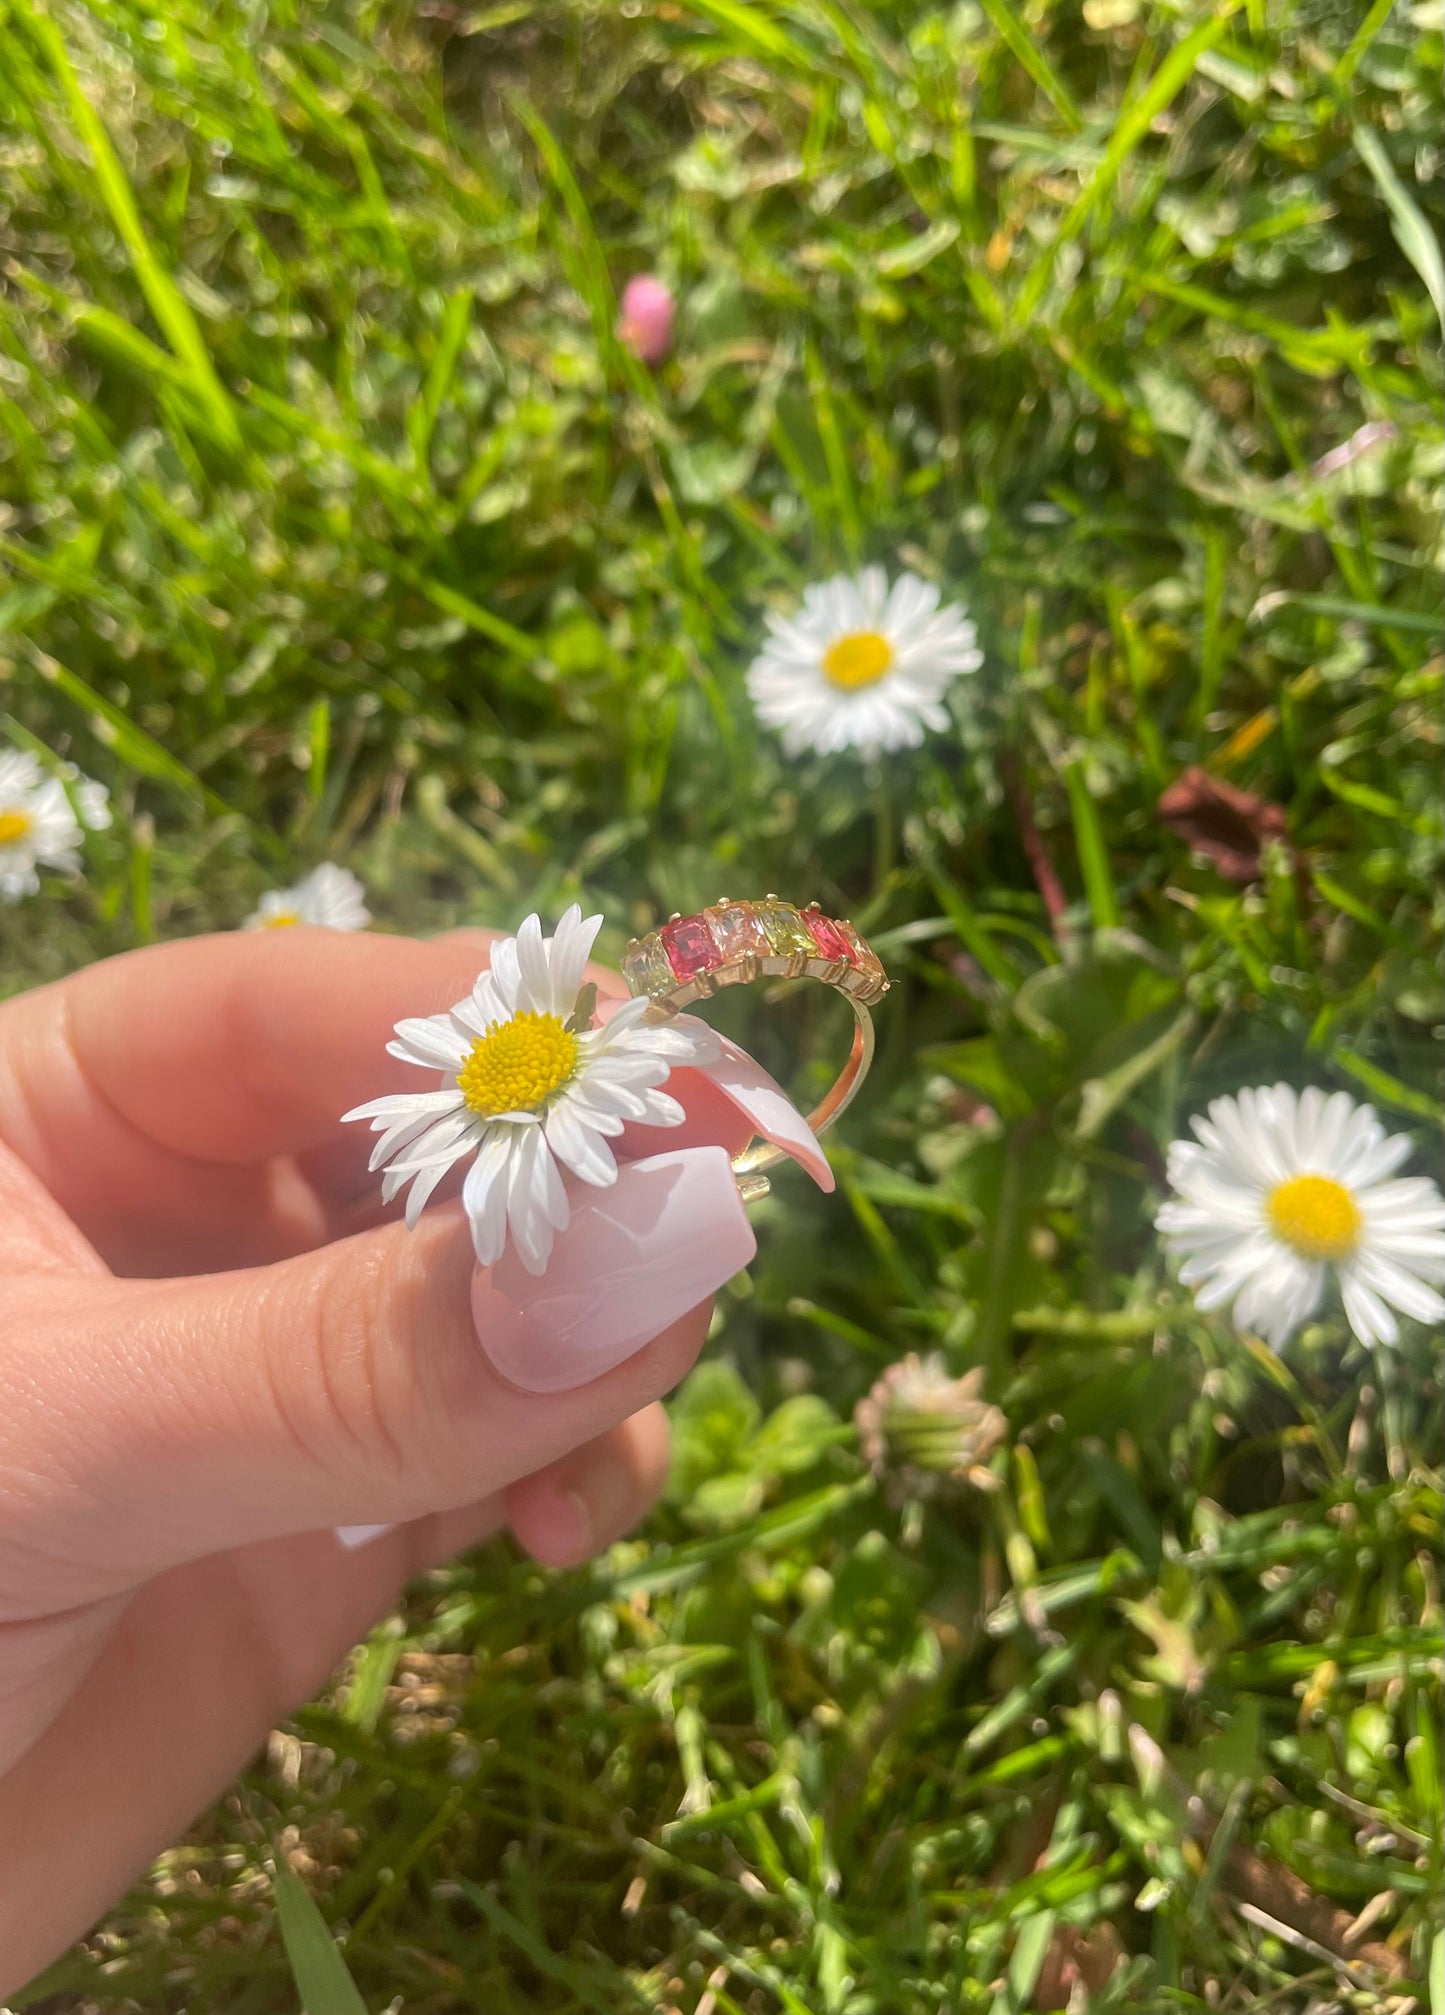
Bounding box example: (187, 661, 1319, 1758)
(0, 1147, 756, 1616)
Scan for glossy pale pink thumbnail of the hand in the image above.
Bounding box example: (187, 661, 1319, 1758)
(472, 1147, 758, 1392)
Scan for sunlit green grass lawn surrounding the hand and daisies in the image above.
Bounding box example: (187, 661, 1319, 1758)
(0, 0, 1445, 2015)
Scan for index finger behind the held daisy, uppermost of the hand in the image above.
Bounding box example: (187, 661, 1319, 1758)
(0, 927, 507, 1225)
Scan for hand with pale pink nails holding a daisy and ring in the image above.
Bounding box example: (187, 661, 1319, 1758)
(0, 929, 752, 1993)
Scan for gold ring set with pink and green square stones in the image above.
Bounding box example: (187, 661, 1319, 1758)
(623, 895, 889, 1201)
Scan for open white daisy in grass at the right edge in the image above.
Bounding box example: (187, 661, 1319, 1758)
(1155, 1084, 1445, 1350)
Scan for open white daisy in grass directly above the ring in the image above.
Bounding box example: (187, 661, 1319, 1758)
(748, 566, 983, 756)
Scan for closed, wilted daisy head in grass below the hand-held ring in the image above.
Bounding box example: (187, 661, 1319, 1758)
(852, 1350, 1008, 1503)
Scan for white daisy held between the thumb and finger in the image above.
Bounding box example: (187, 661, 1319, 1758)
(345, 905, 721, 1273)
